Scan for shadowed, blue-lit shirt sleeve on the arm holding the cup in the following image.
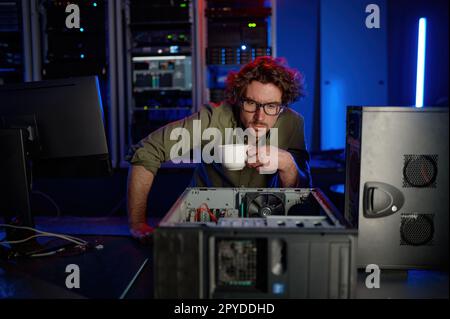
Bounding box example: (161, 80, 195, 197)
(287, 116, 312, 188)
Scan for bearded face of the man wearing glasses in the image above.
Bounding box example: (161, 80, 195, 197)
(240, 81, 282, 136)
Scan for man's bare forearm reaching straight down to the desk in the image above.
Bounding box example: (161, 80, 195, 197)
(127, 166, 154, 225)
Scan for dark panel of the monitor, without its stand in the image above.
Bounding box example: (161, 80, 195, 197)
(0, 76, 111, 176)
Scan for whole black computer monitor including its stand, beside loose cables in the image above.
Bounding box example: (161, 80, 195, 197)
(0, 76, 112, 255)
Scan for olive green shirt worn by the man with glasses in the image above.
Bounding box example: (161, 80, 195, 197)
(128, 103, 311, 187)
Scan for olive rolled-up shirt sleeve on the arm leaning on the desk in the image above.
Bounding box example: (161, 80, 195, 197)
(126, 105, 214, 175)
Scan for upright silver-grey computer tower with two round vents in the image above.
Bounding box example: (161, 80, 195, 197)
(344, 107, 449, 269)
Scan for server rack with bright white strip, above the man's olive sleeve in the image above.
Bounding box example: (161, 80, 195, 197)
(119, 0, 196, 167)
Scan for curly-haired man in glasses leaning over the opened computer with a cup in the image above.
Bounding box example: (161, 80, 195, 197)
(128, 57, 311, 240)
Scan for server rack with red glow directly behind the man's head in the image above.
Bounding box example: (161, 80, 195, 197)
(204, 0, 275, 102)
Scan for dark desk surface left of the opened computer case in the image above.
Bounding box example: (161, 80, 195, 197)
(0, 236, 153, 299)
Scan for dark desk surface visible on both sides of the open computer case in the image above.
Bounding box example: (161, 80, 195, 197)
(0, 219, 449, 299)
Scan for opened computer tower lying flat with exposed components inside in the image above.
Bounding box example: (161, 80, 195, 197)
(153, 188, 357, 299)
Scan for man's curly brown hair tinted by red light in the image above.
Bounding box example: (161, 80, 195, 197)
(225, 56, 305, 106)
